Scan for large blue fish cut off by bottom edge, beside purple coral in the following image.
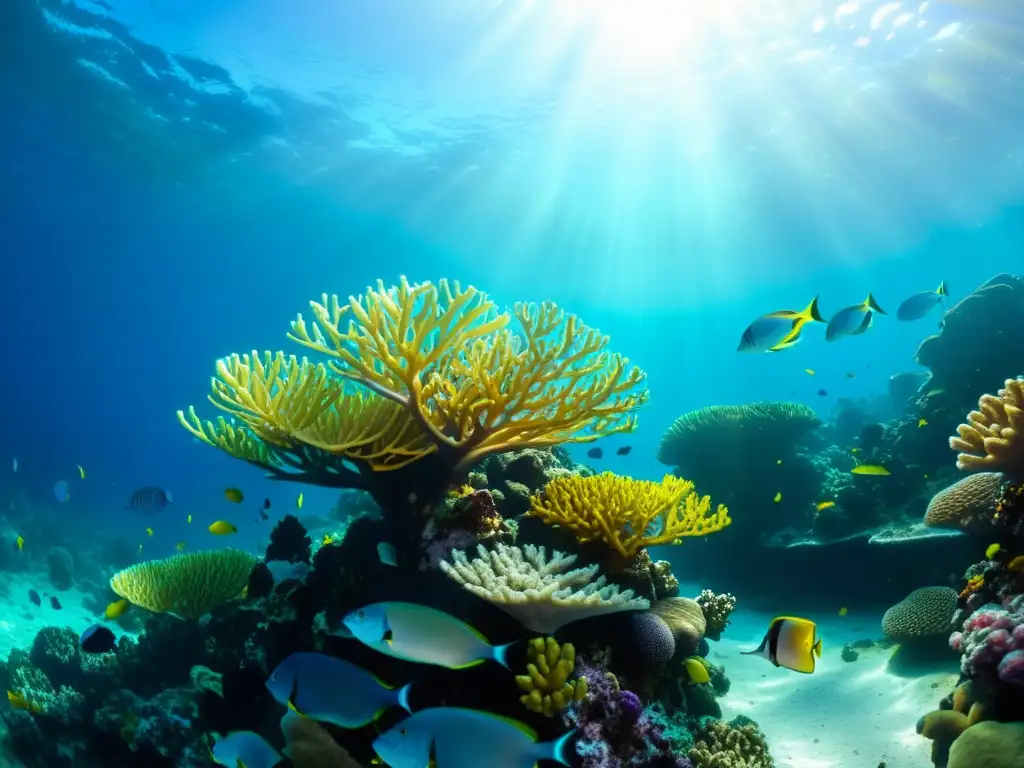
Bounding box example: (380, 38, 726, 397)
(374, 707, 574, 768)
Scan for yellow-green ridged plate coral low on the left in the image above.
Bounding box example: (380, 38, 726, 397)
(111, 549, 258, 618)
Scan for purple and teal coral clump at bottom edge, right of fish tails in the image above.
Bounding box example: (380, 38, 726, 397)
(563, 662, 691, 768)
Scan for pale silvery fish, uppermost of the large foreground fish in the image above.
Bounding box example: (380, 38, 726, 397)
(336, 602, 511, 670)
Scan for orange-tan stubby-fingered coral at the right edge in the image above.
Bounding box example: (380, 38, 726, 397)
(949, 379, 1024, 479)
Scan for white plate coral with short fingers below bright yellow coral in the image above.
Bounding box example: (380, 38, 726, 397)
(440, 544, 650, 634)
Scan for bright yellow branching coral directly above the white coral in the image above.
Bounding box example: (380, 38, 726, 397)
(526, 472, 732, 557)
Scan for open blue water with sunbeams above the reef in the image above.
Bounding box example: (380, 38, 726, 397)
(0, 0, 1024, 555)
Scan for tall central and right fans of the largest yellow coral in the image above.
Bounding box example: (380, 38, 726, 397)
(289, 279, 647, 471)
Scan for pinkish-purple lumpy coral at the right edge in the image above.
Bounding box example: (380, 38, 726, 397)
(949, 596, 1024, 685)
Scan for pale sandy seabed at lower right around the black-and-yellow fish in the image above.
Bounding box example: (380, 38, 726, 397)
(710, 610, 958, 768)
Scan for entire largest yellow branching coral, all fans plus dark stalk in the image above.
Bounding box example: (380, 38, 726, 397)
(178, 278, 647, 562)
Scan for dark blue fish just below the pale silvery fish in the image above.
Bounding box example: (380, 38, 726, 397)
(266, 652, 413, 728)
